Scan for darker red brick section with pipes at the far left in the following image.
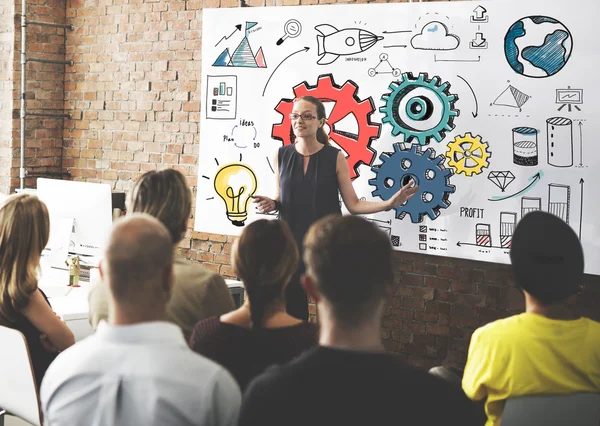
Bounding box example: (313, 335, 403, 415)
(0, 0, 66, 190)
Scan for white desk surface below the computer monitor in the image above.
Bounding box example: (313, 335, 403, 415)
(38, 265, 244, 342)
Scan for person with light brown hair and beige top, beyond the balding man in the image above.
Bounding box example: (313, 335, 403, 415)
(89, 169, 235, 339)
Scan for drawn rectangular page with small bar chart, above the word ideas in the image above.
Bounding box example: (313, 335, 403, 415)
(206, 75, 237, 120)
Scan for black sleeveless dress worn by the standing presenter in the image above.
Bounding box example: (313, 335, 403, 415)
(278, 145, 342, 320)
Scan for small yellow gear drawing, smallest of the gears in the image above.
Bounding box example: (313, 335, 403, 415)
(446, 133, 492, 176)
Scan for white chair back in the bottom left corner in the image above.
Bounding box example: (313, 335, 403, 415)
(0, 326, 42, 426)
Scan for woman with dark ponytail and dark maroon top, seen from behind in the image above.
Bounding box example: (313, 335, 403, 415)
(190, 219, 318, 390)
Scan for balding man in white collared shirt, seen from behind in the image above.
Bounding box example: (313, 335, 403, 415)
(41, 214, 241, 426)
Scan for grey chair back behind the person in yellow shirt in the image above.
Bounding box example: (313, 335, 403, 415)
(500, 393, 600, 426)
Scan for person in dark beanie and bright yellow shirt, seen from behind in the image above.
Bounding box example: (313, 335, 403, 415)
(462, 212, 600, 426)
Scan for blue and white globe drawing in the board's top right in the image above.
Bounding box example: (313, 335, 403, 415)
(504, 16, 573, 78)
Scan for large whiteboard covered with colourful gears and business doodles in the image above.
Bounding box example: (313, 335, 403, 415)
(195, 0, 600, 274)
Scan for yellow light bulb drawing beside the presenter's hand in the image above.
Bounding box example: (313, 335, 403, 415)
(215, 163, 258, 226)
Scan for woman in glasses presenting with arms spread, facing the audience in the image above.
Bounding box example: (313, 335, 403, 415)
(253, 96, 418, 320)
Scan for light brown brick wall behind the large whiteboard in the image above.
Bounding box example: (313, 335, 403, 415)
(5, 0, 600, 367)
